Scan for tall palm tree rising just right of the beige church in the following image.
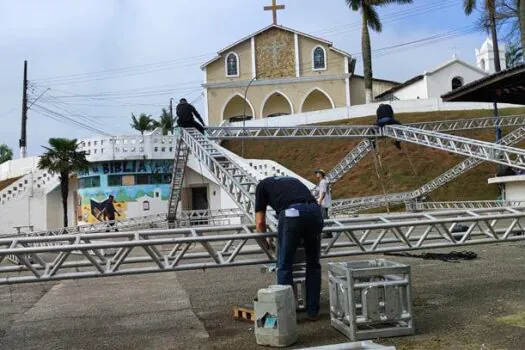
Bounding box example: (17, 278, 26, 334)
(346, 0, 412, 103)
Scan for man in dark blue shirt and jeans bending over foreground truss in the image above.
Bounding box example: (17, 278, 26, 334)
(255, 176, 324, 319)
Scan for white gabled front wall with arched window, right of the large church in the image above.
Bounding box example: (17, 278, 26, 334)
(427, 62, 486, 98)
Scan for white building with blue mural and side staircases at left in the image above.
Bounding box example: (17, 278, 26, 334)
(0, 129, 314, 234)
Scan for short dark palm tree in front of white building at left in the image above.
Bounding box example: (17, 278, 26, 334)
(38, 138, 89, 227)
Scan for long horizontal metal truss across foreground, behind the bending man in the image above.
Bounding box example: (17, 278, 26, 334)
(0, 208, 525, 284)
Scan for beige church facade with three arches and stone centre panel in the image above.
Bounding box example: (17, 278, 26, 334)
(201, 24, 396, 125)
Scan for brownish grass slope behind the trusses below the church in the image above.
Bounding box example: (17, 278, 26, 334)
(223, 108, 525, 201)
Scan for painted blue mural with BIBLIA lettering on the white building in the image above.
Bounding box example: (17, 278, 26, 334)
(76, 160, 172, 224)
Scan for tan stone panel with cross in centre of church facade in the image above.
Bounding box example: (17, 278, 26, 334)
(255, 28, 295, 79)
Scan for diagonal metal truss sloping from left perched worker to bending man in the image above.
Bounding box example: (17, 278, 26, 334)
(181, 128, 277, 228)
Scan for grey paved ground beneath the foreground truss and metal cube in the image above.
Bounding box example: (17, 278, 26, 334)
(0, 243, 525, 350)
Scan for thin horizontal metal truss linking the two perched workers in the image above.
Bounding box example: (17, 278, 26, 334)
(206, 125, 380, 140)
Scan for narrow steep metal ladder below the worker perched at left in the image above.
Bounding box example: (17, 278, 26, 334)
(168, 136, 189, 224)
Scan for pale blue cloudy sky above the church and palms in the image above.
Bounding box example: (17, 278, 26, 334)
(0, 0, 486, 155)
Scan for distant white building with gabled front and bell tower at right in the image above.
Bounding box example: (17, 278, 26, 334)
(376, 38, 505, 101)
